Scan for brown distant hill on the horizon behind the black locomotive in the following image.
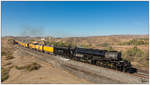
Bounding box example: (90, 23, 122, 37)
(55, 35, 149, 47)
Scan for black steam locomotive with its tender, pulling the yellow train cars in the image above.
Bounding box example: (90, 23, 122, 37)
(54, 47, 137, 73)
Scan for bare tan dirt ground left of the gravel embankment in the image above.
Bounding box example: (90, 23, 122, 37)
(2, 37, 91, 84)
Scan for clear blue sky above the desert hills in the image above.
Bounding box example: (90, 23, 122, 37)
(2, 1, 149, 37)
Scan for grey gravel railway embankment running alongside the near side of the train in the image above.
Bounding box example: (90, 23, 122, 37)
(22, 47, 148, 84)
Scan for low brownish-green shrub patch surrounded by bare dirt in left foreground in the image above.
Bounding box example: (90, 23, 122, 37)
(16, 62, 41, 71)
